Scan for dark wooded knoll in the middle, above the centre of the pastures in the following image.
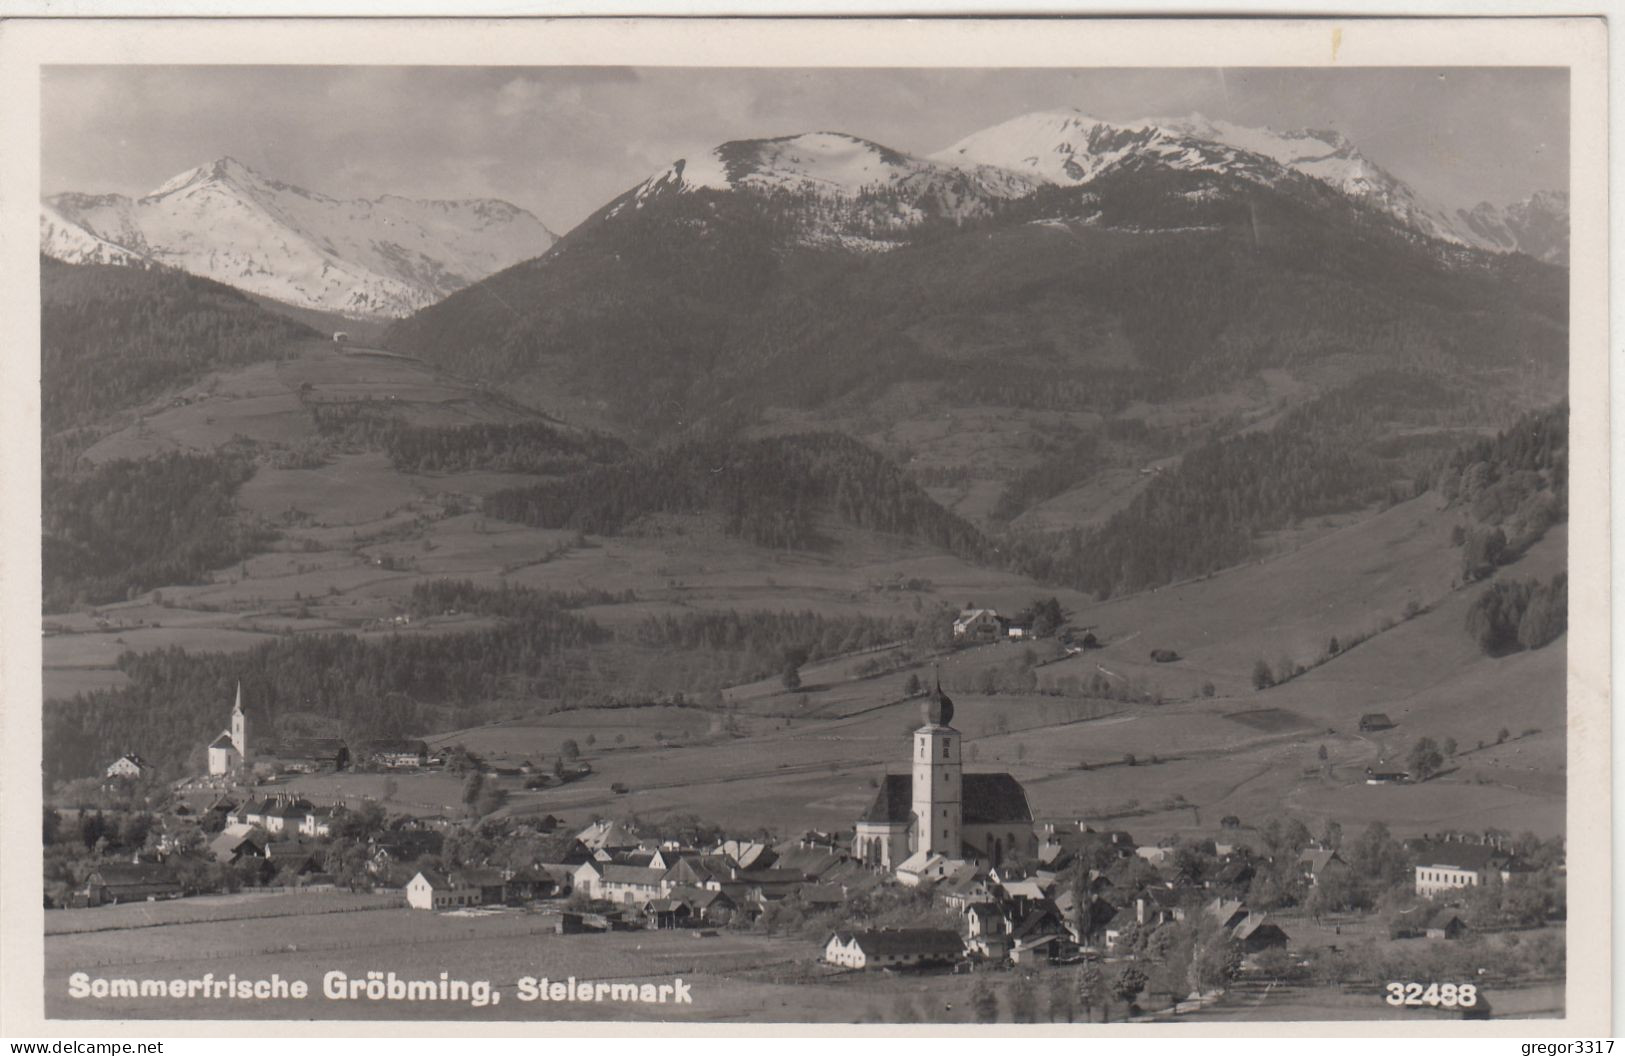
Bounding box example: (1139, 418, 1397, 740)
(484, 432, 990, 559)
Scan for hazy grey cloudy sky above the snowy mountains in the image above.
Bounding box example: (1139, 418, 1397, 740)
(41, 67, 1568, 234)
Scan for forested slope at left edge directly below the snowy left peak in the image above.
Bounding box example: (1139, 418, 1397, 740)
(39, 257, 317, 434)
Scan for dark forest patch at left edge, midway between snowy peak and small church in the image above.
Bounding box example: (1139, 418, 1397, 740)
(42, 448, 273, 612)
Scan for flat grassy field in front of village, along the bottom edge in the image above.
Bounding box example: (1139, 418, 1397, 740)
(46, 894, 1563, 1025)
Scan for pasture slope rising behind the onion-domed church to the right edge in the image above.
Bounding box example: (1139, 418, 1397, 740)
(362, 497, 1567, 840)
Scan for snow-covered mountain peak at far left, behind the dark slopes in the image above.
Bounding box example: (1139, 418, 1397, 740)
(42, 158, 557, 315)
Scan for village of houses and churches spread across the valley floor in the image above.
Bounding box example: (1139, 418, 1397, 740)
(47, 620, 1565, 1022)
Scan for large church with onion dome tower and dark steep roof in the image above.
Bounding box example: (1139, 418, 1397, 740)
(853, 682, 1038, 869)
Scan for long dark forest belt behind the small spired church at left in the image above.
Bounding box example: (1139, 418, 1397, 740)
(44, 580, 938, 786)
